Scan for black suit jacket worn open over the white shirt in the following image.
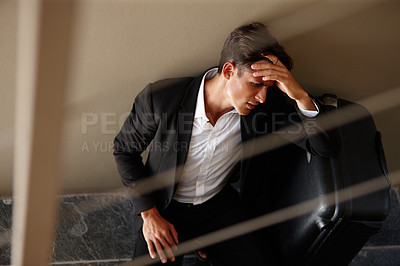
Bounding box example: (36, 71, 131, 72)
(114, 68, 338, 214)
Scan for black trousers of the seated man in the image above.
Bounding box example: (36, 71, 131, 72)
(133, 185, 276, 266)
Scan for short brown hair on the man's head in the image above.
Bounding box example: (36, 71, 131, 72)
(218, 22, 293, 77)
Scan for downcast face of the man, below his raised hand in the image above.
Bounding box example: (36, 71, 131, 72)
(227, 68, 274, 115)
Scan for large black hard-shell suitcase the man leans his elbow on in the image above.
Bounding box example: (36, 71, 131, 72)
(255, 95, 390, 266)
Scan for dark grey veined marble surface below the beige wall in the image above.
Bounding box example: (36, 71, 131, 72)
(0, 188, 400, 266)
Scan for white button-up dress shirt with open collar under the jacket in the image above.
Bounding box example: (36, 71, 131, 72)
(174, 68, 318, 205)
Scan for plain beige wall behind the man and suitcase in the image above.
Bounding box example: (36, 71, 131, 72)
(0, 0, 400, 196)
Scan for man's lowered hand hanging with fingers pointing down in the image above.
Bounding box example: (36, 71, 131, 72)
(141, 207, 178, 263)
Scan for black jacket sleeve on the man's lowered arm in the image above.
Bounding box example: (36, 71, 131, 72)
(113, 84, 158, 214)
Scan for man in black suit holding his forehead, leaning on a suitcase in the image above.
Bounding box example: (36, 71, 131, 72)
(114, 23, 334, 265)
